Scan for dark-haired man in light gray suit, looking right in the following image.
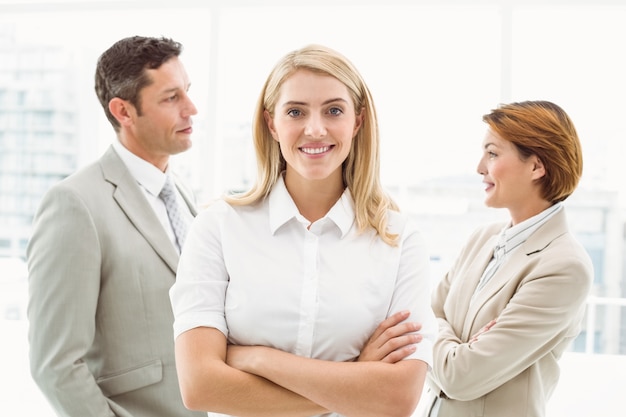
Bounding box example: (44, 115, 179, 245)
(27, 36, 206, 417)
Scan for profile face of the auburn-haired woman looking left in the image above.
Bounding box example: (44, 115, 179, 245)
(477, 129, 545, 223)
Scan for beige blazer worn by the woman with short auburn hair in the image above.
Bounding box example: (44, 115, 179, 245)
(422, 210, 593, 417)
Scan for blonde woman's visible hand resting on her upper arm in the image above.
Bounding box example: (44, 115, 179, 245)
(357, 311, 422, 363)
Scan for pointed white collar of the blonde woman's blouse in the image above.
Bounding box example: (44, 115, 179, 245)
(269, 175, 355, 238)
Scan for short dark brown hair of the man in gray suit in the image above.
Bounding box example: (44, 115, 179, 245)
(95, 36, 183, 132)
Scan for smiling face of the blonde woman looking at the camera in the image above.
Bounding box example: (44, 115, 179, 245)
(265, 70, 363, 185)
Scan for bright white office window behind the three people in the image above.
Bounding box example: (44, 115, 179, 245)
(0, 0, 626, 417)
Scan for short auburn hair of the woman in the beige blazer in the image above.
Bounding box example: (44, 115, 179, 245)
(483, 101, 583, 204)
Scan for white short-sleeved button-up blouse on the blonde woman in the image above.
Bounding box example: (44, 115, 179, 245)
(170, 178, 437, 367)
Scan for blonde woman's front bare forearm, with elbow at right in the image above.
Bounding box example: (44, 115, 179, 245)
(228, 346, 428, 416)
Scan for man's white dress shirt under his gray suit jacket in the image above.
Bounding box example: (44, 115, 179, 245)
(113, 140, 193, 250)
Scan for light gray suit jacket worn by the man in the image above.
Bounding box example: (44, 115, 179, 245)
(27, 147, 206, 417)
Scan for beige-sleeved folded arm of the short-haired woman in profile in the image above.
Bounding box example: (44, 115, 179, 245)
(433, 255, 588, 401)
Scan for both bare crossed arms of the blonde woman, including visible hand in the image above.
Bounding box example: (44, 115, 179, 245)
(176, 312, 427, 416)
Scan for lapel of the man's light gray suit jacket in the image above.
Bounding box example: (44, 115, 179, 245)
(100, 146, 178, 273)
